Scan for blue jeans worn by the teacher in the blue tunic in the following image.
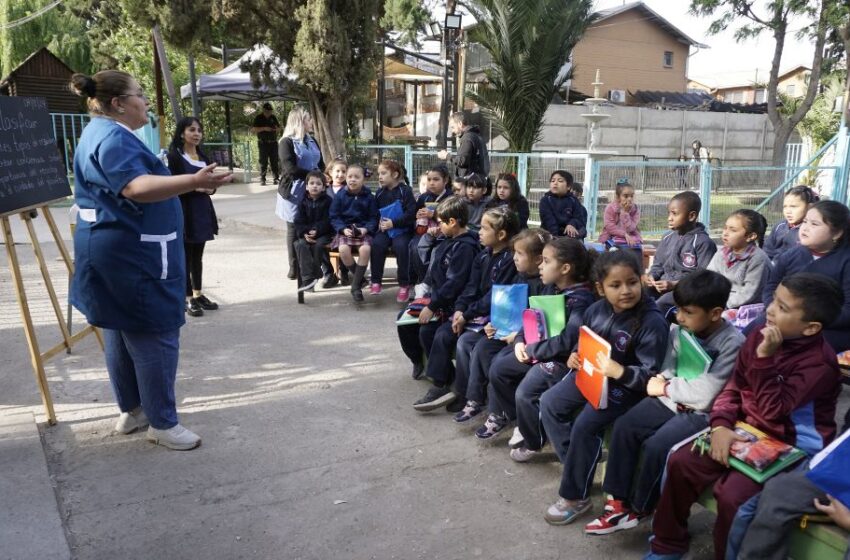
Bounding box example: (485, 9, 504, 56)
(103, 329, 180, 430)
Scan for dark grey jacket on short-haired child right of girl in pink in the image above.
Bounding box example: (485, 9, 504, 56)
(649, 223, 717, 282)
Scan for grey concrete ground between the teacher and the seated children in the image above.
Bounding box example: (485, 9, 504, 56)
(0, 185, 836, 560)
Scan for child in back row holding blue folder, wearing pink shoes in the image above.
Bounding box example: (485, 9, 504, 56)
(369, 159, 416, 303)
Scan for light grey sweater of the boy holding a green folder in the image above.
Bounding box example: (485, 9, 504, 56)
(658, 319, 744, 413)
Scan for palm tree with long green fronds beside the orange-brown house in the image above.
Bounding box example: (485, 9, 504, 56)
(468, 0, 593, 152)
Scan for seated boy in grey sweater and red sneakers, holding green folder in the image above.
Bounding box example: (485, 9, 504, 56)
(584, 270, 744, 535)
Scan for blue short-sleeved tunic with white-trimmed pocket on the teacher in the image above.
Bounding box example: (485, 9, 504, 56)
(69, 117, 186, 332)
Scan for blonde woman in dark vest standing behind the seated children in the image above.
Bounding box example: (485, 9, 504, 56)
(276, 105, 327, 280)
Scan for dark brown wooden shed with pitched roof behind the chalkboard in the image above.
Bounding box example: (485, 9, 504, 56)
(0, 47, 84, 113)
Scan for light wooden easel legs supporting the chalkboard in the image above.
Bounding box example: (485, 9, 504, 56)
(0, 204, 103, 425)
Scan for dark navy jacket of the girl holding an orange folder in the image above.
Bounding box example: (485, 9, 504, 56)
(571, 295, 670, 395)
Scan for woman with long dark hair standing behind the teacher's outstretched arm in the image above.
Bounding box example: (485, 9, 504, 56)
(168, 117, 218, 317)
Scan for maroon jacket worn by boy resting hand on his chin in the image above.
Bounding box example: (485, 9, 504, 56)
(711, 330, 841, 455)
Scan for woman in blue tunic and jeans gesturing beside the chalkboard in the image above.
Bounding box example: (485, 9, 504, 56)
(69, 70, 231, 449)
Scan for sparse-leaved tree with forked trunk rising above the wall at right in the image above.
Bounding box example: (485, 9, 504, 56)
(691, 0, 837, 165)
